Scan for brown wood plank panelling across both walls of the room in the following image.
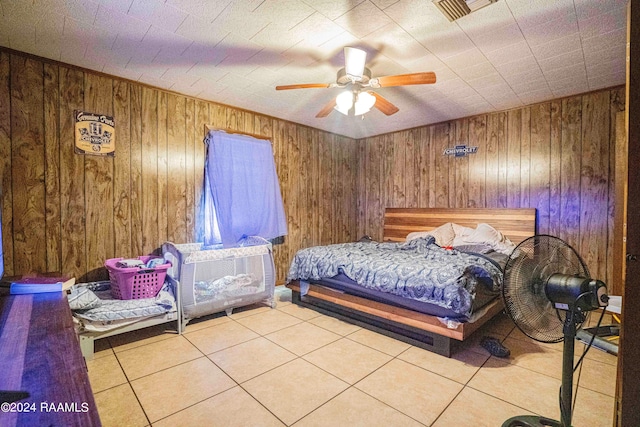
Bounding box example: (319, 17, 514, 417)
(0, 50, 624, 291)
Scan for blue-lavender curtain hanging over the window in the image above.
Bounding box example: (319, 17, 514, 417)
(203, 131, 287, 247)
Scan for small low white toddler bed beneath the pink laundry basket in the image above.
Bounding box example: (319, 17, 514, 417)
(67, 277, 182, 360)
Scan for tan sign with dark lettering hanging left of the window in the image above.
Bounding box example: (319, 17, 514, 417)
(74, 110, 116, 157)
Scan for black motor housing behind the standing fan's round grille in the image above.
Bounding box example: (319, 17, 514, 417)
(545, 273, 609, 311)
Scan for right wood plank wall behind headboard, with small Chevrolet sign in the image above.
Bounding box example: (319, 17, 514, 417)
(357, 88, 625, 295)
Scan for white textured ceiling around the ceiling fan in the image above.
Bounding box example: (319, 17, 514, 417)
(0, 0, 626, 138)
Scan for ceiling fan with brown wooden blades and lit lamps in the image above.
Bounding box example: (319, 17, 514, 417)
(276, 47, 436, 118)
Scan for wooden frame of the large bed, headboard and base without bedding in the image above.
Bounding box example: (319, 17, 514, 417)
(287, 208, 536, 357)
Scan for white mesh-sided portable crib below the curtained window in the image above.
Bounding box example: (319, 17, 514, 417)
(162, 240, 275, 329)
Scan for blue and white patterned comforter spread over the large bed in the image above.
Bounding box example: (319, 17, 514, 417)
(287, 236, 502, 316)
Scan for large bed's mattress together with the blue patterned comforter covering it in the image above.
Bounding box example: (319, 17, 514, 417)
(288, 237, 507, 321)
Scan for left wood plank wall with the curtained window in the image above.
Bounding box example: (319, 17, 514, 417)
(0, 50, 357, 281)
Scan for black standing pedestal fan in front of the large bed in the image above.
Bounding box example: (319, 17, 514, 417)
(502, 235, 609, 427)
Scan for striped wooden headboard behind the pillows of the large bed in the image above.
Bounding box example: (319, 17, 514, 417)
(384, 208, 536, 245)
